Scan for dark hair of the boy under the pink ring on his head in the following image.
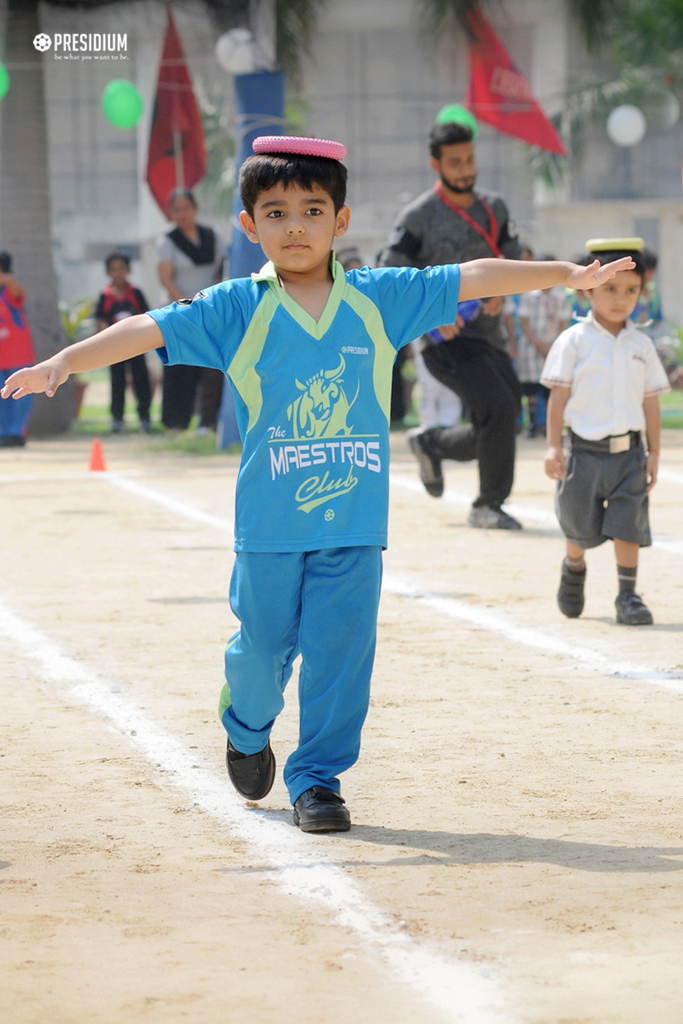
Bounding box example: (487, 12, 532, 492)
(240, 153, 348, 217)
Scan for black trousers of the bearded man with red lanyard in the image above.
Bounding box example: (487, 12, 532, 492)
(422, 335, 521, 508)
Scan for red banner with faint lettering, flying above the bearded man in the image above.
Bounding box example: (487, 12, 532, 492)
(465, 8, 566, 157)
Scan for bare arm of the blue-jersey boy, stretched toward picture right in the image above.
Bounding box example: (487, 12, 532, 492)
(459, 256, 636, 302)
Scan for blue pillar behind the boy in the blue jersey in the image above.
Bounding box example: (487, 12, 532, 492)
(216, 71, 285, 449)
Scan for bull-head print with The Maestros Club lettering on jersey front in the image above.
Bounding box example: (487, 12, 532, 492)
(268, 355, 382, 518)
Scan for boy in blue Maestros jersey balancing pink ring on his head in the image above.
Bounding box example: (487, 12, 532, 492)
(1, 136, 632, 831)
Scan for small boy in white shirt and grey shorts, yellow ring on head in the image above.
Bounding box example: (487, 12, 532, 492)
(541, 239, 670, 626)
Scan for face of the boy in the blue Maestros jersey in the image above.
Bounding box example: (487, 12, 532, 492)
(240, 183, 350, 273)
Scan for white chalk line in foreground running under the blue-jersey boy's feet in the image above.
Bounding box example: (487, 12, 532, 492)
(0, 598, 510, 1024)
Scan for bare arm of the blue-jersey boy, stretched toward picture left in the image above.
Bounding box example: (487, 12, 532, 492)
(0, 313, 164, 398)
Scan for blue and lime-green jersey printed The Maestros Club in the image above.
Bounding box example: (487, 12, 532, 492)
(148, 253, 460, 551)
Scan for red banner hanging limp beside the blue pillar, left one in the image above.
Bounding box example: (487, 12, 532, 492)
(147, 10, 207, 216)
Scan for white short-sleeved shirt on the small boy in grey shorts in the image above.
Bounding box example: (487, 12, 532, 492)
(541, 311, 671, 441)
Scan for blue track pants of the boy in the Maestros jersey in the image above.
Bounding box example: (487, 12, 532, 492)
(220, 547, 382, 803)
